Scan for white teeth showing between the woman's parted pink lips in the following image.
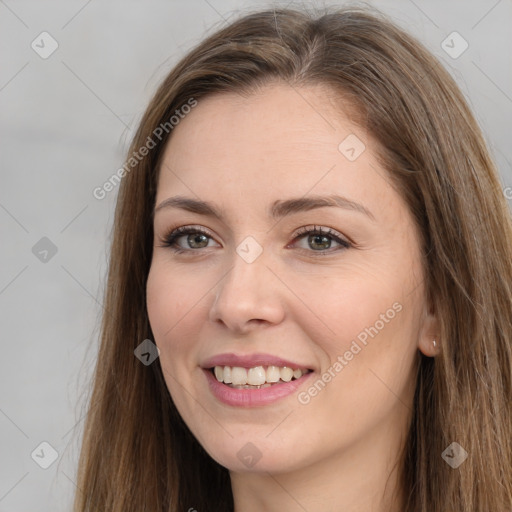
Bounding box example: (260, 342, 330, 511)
(210, 366, 312, 389)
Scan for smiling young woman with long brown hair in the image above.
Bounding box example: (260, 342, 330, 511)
(75, 8, 512, 512)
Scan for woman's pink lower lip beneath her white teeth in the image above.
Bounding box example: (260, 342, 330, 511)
(203, 369, 313, 407)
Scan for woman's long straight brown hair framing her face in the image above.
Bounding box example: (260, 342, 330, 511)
(74, 7, 512, 512)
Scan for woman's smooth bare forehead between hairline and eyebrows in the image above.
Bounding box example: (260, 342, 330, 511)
(157, 85, 396, 222)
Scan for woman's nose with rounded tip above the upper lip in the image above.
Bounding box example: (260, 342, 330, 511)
(209, 243, 285, 334)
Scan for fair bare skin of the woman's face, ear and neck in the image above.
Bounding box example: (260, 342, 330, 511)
(147, 84, 439, 512)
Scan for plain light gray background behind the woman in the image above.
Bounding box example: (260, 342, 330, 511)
(0, 0, 512, 512)
